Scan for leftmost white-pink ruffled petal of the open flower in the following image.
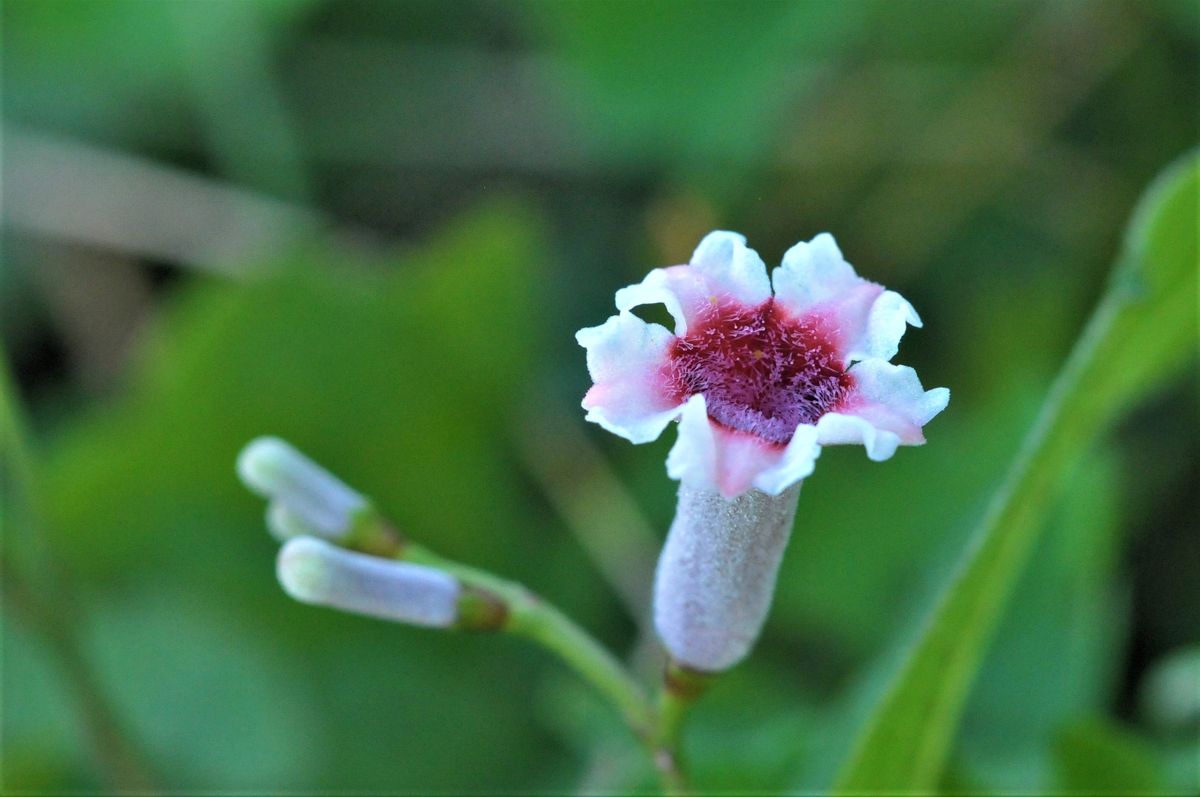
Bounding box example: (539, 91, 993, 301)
(575, 312, 679, 443)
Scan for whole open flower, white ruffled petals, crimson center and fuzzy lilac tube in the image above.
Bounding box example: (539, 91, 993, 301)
(576, 232, 949, 672)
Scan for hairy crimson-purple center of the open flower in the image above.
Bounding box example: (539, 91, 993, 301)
(665, 299, 850, 445)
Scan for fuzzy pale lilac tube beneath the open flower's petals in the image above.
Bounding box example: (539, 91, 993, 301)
(654, 481, 800, 672)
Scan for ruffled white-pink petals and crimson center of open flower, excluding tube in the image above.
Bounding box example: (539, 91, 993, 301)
(576, 226, 949, 498)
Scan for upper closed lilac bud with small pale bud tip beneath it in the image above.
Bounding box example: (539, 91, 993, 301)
(238, 437, 367, 541)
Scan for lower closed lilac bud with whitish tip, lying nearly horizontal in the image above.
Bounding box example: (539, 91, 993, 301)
(276, 537, 462, 628)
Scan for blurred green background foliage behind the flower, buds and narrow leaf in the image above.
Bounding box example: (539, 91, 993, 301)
(0, 0, 1200, 792)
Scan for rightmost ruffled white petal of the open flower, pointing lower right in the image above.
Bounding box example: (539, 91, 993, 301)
(816, 359, 950, 462)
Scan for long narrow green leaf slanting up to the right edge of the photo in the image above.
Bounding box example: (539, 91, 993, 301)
(836, 154, 1200, 792)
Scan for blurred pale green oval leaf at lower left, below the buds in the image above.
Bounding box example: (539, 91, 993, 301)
(89, 579, 330, 791)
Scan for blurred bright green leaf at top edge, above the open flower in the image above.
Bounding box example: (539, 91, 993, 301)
(528, 0, 868, 189)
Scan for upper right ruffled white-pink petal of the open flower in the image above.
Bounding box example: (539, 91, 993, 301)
(772, 233, 922, 365)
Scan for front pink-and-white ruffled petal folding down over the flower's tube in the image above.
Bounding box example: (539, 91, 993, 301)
(667, 394, 821, 498)
